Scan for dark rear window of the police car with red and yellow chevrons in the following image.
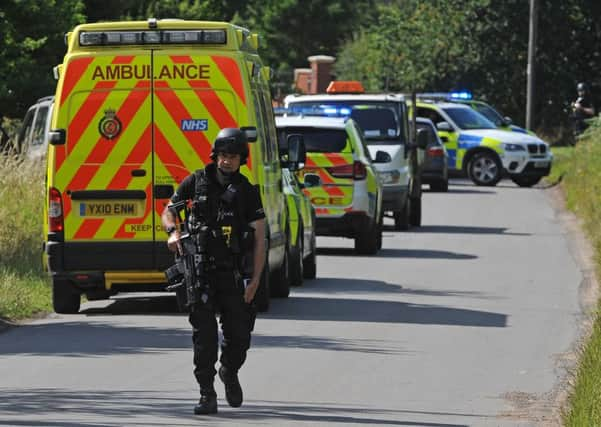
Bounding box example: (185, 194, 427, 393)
(278, 127, 347, 153)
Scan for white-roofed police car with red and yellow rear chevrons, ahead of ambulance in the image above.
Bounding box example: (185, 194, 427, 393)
(276, 116, 382, 255)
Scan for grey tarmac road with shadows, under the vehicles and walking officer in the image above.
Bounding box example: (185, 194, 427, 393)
(0, 180, 583, 427)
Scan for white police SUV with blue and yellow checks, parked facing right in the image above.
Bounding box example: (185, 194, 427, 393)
(410, 99, 553, 187)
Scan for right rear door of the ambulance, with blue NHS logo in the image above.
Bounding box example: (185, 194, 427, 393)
(152, 47, 247, 267)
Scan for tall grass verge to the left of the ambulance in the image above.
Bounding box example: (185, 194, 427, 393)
(0, 156, 52, 320)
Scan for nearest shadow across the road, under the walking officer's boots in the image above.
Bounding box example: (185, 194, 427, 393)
(0, 388, 482, 427)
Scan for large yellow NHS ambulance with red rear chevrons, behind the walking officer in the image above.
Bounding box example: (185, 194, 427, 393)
(44, 19, 289, 313)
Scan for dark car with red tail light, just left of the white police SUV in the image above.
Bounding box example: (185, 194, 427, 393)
(416, 117, 449, 191)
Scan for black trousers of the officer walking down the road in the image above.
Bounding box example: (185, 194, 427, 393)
(189, 272, 254, 390)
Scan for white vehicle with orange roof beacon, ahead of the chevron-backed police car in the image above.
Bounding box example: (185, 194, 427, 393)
(284, 81, 425, 230)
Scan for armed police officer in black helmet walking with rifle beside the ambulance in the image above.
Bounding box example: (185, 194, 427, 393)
(162, 128, 266, 414)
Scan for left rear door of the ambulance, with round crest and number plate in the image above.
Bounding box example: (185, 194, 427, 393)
(54, 49, 154, 264)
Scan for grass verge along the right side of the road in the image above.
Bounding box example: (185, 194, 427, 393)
(550, 129, 601, 427)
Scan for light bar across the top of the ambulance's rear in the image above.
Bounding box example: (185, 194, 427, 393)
(79, 30, 227, 46)
